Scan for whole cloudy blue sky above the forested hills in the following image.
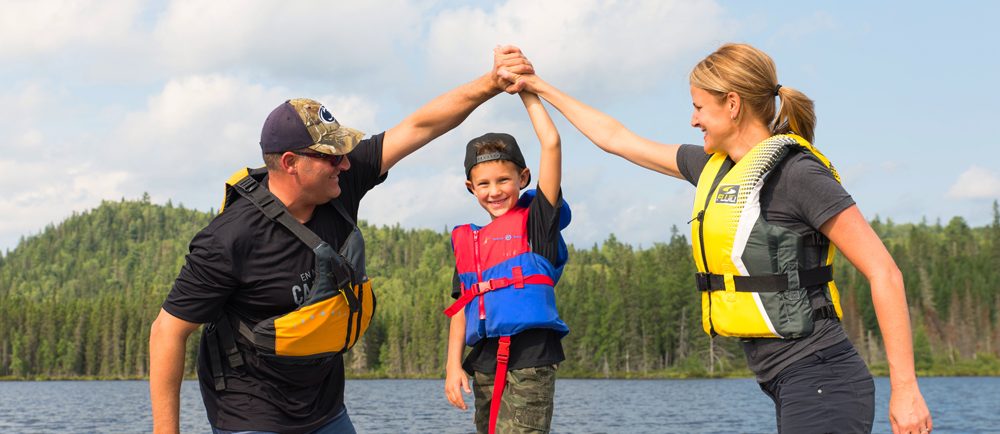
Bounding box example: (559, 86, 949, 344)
(0, 0, 1000, 252)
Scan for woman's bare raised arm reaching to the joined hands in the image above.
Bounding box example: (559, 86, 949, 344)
(499, 49, 681, 178)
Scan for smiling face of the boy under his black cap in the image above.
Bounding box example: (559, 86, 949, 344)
(465, 160, 528, 219)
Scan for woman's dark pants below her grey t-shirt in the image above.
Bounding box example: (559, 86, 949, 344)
(760, 339, 875, 434)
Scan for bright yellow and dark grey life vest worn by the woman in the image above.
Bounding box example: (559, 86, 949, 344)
(691, 134, 843, 339)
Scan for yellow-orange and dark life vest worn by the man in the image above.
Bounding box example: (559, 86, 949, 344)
(206, 168, 375, 390)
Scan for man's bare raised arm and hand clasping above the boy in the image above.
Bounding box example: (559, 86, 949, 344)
(382, 50, 534, 173)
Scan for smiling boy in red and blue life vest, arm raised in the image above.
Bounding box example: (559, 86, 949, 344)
(445, 92, 570, 434)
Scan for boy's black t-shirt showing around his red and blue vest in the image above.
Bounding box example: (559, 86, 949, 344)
(451, 190, 566, 375)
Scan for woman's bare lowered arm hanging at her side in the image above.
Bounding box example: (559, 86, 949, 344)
(820, 205, 934, 433)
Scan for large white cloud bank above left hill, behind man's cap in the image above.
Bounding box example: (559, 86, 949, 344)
(0, 75, 377, 251)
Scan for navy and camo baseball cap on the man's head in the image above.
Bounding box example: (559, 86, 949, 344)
(260, 98, 365, 155)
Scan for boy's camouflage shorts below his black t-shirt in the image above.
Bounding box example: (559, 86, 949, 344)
(472, 365, 557, 434)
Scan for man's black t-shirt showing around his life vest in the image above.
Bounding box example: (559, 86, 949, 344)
(163, 134, 385, 432)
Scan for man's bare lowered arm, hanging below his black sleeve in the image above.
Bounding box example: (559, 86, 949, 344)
(149, 309, 201, 433)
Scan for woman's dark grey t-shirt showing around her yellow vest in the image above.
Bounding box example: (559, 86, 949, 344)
(677, 145, 854, 383)
